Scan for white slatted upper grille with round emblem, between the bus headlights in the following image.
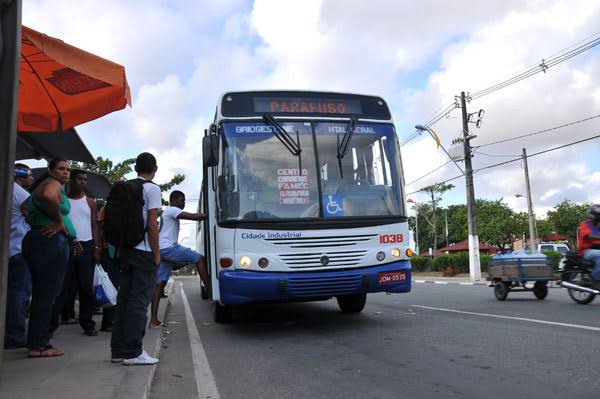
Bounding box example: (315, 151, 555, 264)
(279, 251, 367, 269)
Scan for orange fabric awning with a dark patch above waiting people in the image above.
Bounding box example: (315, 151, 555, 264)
(17, 26, 131, 132)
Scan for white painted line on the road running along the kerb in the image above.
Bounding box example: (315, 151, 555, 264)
(179, 283, 220, 399)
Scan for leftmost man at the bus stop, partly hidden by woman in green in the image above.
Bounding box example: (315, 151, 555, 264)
(4, 163, 33, 349)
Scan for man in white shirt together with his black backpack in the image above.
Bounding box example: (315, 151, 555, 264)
(103, 152, 162, 366)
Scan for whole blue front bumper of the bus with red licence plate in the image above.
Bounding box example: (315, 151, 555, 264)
(219, 261, 411, 305)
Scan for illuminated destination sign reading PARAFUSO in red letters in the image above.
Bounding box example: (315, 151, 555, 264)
(254, 97, 362, 115)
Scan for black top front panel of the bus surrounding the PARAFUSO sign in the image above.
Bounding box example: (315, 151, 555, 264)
(217, 90, 391, 121)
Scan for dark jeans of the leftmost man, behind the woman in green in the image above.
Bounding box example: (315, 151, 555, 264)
(4, 253, 31, 347)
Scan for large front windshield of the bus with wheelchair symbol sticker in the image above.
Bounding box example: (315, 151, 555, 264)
(218, 120, 404, 222)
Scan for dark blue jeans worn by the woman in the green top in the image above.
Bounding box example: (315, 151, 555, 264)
(23, 229, 69, 350)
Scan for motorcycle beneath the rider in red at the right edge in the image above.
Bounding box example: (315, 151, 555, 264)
(560, 252, 600, 305)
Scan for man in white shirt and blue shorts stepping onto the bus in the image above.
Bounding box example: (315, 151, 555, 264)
(149, 190, 210, 328)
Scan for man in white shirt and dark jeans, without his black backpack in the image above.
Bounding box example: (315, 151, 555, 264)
(110, 152, 162, 366)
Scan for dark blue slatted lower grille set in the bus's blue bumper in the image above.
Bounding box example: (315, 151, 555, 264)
(287, 273, 365, 297)
